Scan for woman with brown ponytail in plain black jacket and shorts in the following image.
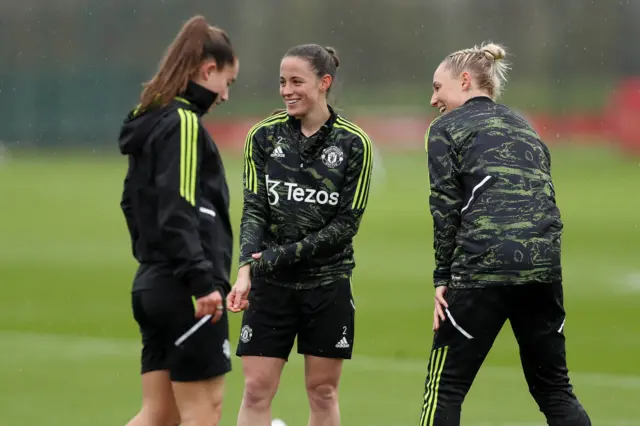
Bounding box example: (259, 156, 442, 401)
(119, 16, 238, 426)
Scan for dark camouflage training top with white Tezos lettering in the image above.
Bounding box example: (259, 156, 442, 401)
(239, 109, 373, 289)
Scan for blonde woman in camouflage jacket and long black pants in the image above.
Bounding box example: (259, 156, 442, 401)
(420, 43, 591, 426)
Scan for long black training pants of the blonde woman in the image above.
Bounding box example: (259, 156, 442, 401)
(420, 282, 591, 426)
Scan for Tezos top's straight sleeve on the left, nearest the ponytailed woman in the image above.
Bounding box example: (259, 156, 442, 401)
(239, 129, 269, 267)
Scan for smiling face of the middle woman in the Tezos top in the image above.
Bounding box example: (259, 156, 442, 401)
(280, 56, 332, 118)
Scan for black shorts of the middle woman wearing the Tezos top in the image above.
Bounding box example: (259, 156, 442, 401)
(236, 279, 355, 360)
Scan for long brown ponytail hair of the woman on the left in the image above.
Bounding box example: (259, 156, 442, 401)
(139, 15, 235, 110)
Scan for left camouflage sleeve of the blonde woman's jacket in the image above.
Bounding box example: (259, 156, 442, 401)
(425, 123, 463, 287)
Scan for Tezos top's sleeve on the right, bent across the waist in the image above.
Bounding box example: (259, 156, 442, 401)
(261, 133, 373, 268)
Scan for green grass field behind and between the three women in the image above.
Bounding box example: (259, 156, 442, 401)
(0, 148, 640, 426)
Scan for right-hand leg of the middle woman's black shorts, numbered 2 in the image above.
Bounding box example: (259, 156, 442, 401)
(298, 279, 355, 359)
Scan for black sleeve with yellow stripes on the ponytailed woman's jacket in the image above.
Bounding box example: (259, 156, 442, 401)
(153, 109, 216, 297)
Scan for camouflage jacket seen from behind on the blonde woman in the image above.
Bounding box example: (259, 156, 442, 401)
(426, 97, 563, 288)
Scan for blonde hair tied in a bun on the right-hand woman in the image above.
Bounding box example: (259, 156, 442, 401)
(444, 43, 511, 100)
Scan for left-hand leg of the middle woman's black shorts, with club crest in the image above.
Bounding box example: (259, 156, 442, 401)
(236, 280, 299, 360)
